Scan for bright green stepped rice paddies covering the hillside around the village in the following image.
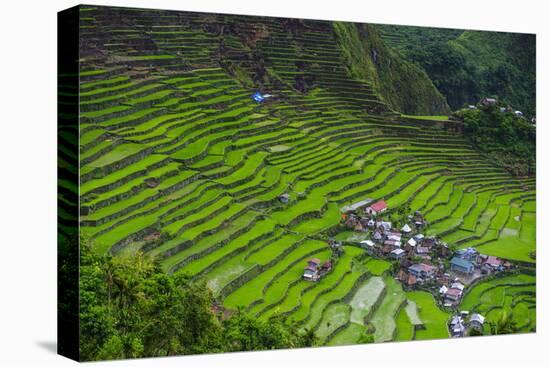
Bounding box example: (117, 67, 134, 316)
(66, 8, 535, 345)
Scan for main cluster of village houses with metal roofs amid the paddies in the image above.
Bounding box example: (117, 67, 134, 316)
(342, 199, 512, 307)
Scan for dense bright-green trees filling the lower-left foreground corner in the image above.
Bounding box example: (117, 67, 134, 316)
(80, 244, 315, 361)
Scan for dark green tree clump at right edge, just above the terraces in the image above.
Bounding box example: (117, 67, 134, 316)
(456, 106, 536, 176)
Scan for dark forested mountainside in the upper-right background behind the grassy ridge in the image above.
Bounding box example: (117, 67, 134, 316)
(376, 25, 536, 116)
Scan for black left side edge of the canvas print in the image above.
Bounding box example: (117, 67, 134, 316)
(57, 6, 80, 360)
